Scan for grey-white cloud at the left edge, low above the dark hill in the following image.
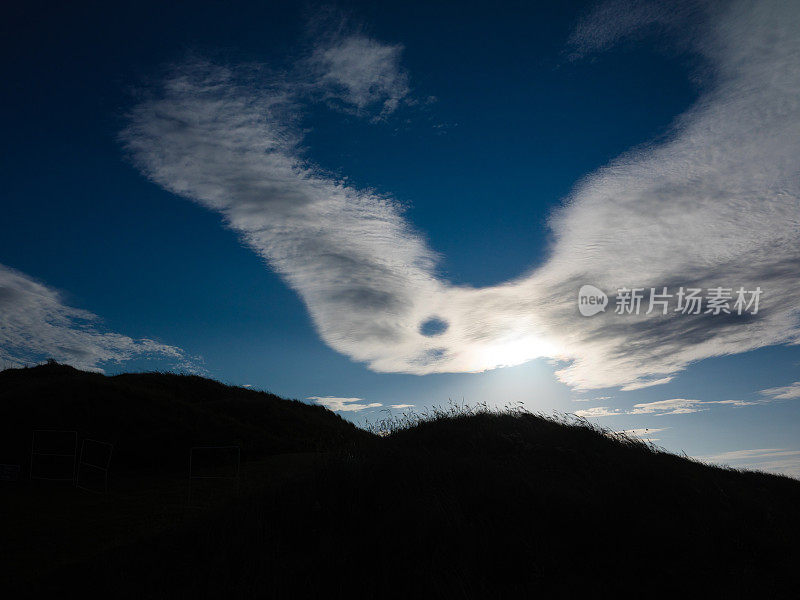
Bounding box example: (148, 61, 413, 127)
(0, 265, 186, 371)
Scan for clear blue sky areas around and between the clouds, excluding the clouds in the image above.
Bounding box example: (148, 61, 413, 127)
(0, 2, 800, 478)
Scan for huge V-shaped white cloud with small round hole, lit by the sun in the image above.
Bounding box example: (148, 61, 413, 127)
(122, 2, 800, 394)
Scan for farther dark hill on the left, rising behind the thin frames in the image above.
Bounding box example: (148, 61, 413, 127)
(0, 364, 366, 470)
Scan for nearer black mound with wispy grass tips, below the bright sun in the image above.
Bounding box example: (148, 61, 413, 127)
(1, 366, 800, 598)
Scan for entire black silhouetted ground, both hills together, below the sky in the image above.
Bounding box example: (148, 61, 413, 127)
(0, 365, 800, 598)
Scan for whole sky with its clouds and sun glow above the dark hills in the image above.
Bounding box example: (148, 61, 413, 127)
(0, 0, 800, 477)
